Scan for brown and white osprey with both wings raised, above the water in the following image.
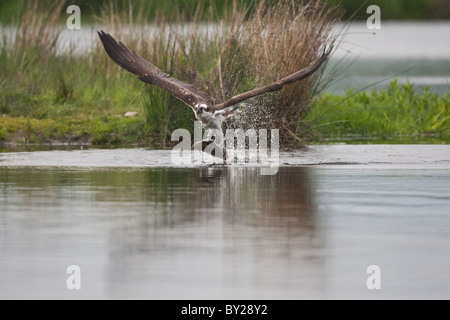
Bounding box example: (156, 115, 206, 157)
(98, 30, 333, 130)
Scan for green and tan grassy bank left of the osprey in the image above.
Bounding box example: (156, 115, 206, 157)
(0, 0, 149, 144)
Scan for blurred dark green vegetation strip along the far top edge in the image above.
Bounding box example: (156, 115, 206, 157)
(0, 0, 450, 24)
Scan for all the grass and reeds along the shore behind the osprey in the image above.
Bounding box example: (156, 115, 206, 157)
(0, 0, 450, 148)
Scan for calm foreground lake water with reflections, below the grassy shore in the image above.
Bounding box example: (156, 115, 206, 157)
(0, 145, 450, 299)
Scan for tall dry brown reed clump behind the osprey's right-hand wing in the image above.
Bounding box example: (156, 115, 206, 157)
(221, 1, 340, 145)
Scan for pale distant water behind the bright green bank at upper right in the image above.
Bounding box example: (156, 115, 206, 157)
(325, 21, 450, 95)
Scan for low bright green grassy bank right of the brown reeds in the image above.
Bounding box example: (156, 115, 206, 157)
(304, 81, 450, 143)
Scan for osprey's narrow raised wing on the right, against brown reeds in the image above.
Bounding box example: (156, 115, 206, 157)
(213, 46, 333, 111)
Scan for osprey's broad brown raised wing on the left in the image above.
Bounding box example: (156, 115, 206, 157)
(98, 30, 212, 108)
